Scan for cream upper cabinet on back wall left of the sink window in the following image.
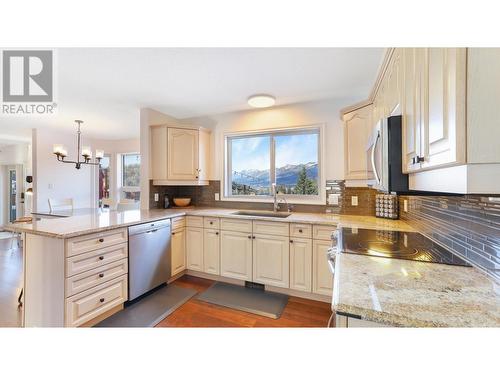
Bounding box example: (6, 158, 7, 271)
(150, 126, 210, 185)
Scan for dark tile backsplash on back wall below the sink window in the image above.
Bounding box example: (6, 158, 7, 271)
(149, 181, 376, 215)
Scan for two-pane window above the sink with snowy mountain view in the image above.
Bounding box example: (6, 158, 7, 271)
(225, 129, 320, 197)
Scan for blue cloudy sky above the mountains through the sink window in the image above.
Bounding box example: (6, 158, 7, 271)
(231, 134, 318, 171)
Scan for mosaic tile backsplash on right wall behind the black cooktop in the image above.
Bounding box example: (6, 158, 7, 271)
(399, 196, 500, 281)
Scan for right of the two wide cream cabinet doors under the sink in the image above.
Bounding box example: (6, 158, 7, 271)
(253, 234, 290, 288)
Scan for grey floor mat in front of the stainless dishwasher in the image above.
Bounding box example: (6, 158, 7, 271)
(96, 285, 197, 327)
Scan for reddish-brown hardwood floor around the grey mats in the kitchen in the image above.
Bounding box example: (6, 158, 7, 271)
(157, 275, 331, 327)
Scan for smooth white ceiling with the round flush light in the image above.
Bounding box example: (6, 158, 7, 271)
(0, 48, 384, 139)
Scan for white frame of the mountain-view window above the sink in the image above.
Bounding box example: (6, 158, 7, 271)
(221, 124, 326, 205)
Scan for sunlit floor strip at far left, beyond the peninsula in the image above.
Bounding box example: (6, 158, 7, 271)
(0, 239, 23, 328)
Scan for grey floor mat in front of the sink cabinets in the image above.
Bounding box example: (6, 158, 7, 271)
(196, 282, 288, 319)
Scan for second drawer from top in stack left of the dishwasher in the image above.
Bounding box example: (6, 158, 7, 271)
(66, 242, 128, 277)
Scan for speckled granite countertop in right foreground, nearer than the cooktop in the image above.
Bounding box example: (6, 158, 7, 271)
(332, 253, 500, 327)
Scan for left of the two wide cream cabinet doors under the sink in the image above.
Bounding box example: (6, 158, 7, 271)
(220, 231, 252, 281)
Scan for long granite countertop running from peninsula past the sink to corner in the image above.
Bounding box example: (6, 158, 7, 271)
(6, 207, 412, 238)
